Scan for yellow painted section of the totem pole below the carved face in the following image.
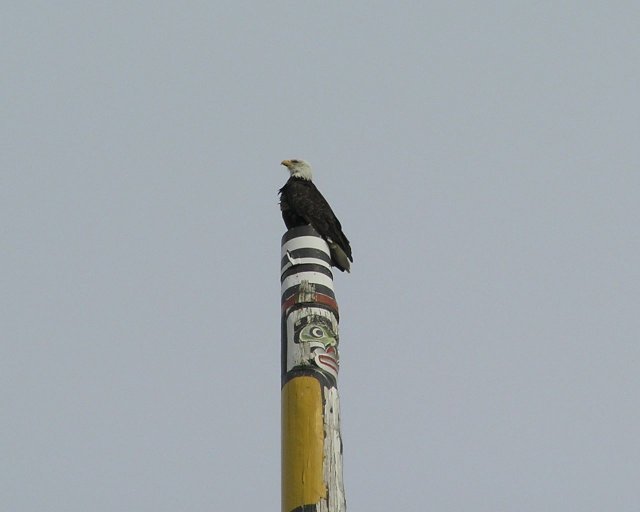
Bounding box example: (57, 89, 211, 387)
(282, 376, 327, 512)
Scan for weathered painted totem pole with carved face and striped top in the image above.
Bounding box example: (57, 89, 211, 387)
(280, 226, 346, 512)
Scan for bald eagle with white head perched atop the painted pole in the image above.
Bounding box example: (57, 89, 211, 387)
(280, 160, 353, 272)
